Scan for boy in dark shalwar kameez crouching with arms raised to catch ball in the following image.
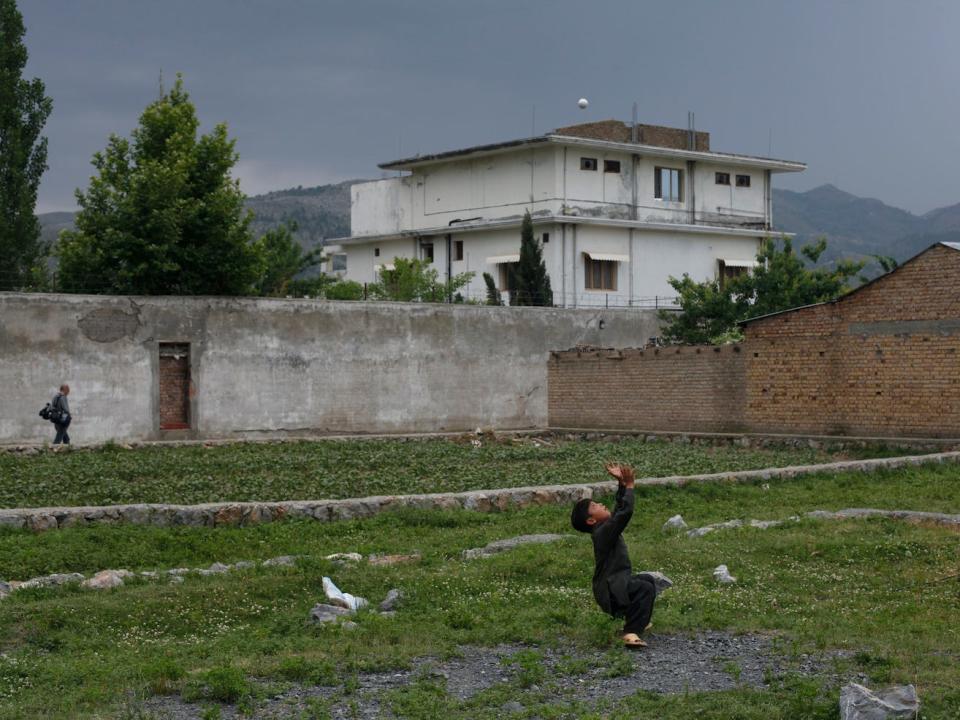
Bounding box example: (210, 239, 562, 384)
(570, 464, 657, 648)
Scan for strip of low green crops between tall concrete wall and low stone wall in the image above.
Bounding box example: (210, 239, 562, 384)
(0, 437, 924, 507)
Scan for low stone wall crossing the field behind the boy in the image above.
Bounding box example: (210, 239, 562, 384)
(0, 452, 960, 531)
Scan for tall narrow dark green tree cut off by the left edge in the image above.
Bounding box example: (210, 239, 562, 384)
(0, 0, 53, 290)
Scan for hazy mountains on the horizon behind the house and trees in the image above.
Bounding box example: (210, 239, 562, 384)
(39, 180, 960, 275)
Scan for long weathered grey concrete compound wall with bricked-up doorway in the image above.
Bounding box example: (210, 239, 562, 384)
(0, 293, 659, 443)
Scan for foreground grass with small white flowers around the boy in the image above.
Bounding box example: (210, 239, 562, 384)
(0, 464, 960, 720)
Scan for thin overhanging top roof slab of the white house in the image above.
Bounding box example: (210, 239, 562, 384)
(378, 133, 807, 172)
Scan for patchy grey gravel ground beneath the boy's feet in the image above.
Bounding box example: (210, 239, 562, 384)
(135, 631, 865, 720)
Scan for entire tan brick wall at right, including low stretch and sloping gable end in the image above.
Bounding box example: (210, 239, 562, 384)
(548, 245, 960, 437)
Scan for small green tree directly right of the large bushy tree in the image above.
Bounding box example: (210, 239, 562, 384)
(253, 223, 324, 297)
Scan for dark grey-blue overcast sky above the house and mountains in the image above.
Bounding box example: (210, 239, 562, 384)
(19, 0, 960, 213)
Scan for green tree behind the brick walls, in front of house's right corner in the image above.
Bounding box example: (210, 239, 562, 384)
(660, 237, 864, 344)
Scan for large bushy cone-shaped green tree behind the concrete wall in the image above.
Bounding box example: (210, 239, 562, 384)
(58, 75, 262, 295)
